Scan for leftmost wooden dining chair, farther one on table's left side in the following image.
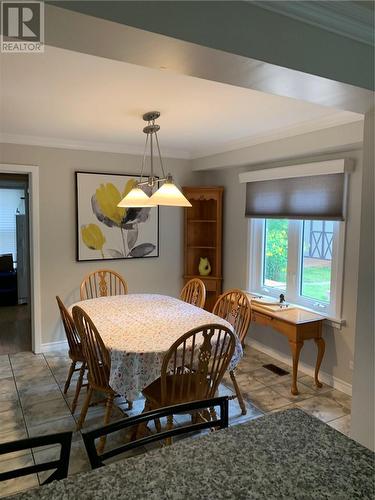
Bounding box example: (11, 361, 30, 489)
(56, 296, 86, 413)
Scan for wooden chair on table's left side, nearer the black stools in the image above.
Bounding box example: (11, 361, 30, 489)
(73, 306, 122, 451)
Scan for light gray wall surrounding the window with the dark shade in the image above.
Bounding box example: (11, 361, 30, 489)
(204, 148, 362, 384)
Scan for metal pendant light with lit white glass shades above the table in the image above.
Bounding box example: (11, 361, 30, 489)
(118, 111, 191, 207)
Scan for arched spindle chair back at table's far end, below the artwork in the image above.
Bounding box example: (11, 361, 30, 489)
(80, 269, 128, 300)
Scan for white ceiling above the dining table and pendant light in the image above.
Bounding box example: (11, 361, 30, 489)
(0, 46, 362, 158)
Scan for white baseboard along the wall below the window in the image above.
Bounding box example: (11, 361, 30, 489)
(246, 338, 352, 396)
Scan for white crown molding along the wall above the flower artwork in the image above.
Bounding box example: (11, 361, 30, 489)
(0, 133, 191, 160)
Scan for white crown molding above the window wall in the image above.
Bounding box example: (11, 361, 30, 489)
(191, 114, 364, 160)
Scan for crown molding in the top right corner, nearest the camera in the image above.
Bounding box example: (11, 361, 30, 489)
(251, 0, 374, 47)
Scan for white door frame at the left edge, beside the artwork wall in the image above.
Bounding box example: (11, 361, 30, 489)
(0, 163, 42, 353)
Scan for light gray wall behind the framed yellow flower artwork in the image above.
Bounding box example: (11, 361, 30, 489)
(0, 144, 199, 343)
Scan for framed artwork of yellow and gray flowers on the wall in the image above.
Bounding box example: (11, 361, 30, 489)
(76, 172, 159, 261)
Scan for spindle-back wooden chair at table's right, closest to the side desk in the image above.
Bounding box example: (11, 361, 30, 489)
(212, 288, 251, 415)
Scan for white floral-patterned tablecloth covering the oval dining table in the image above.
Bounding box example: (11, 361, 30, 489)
(70, 294, 242, 401)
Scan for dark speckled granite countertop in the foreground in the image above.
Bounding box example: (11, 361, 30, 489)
(6, 409, 375, 500)
